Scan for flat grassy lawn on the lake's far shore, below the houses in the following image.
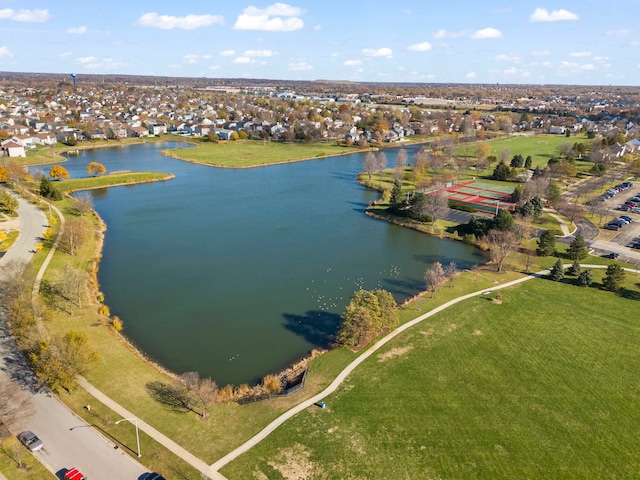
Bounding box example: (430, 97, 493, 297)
(167, 140, 358, 168)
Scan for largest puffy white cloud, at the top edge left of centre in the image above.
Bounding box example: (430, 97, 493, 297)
(233, 3, 304, 32)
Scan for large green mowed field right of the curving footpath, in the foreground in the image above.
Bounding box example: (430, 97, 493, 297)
(221, 272, 640, 480)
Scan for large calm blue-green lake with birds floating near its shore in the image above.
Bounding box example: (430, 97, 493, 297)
(42, 143, 482, 385)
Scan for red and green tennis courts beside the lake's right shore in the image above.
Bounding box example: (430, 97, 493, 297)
(431, 181, 516, 213)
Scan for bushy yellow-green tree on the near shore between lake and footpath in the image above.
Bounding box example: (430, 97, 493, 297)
(337, 290, 400, 349)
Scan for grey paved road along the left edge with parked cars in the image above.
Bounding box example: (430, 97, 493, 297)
(0, 190, 146, 480)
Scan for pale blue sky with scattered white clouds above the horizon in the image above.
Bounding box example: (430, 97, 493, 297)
(0, 0, 640, 85)
